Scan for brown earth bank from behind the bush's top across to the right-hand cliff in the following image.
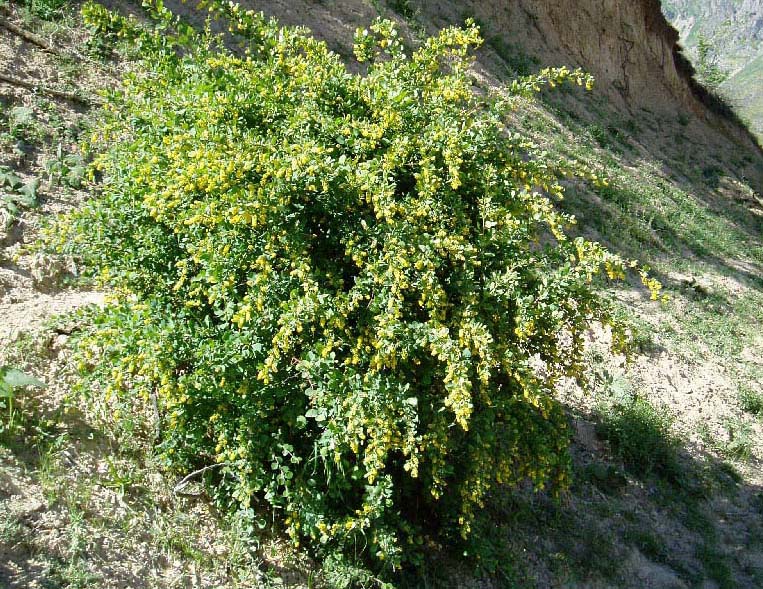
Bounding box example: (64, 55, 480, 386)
(206, 0, 763, 181)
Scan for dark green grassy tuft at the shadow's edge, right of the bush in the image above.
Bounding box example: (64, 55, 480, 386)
(599, 396, 681, 482)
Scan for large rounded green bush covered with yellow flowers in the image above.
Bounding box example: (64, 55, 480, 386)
(56, 4, 658, 567)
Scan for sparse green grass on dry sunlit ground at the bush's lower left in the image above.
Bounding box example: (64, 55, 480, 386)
(0, 323, 308, 589)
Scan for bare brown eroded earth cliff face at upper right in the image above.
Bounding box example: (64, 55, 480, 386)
(412, 0, 763, 186)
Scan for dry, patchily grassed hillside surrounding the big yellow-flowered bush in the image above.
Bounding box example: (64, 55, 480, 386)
(0, 0, 763, 589)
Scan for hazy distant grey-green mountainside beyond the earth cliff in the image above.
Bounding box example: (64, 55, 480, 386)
(663, 0, 763, 135)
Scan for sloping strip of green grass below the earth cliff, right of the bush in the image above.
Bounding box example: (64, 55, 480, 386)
(518, 97, 763, 271)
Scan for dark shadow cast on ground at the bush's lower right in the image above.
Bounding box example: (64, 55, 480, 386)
(403, 400, 763, 589)
